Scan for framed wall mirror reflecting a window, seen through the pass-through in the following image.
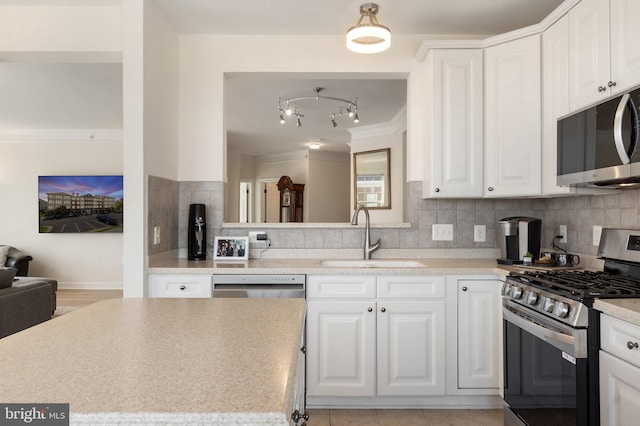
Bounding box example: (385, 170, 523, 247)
(353, 148, 391, 209)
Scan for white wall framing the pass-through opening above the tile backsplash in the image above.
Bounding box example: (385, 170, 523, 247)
(179, 35, 426, 186)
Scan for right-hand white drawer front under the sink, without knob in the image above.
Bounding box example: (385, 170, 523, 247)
(378, 275, 445, 299)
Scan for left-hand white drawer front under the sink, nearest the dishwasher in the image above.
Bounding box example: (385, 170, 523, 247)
(307, 275, 376, 299)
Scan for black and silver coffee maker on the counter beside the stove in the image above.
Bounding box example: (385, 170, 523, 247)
(497, 216, 542, 265)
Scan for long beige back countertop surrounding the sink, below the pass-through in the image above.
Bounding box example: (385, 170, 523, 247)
(148, 255, 514, 275)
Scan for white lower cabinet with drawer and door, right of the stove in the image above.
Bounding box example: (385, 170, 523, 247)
(600, 315, 640, 426)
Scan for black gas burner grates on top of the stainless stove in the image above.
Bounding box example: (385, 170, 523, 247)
(512, 271, 640, 299)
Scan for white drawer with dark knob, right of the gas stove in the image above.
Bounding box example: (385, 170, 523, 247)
(600, 315, 640, 367)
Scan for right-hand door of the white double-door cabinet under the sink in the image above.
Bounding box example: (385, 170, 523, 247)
(377, 300, 445, 395)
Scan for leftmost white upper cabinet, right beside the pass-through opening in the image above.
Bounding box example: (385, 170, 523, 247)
(423, 49, 483, 198)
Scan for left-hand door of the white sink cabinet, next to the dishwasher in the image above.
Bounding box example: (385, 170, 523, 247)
(307, 301, 376, 396)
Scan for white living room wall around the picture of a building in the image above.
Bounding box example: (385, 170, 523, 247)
(0, 140, 123, 288)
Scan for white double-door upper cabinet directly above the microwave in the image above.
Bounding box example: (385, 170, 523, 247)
(569, 0, 640, 111)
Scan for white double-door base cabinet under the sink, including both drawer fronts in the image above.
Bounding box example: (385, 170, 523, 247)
(307, 276, 445, 397)
